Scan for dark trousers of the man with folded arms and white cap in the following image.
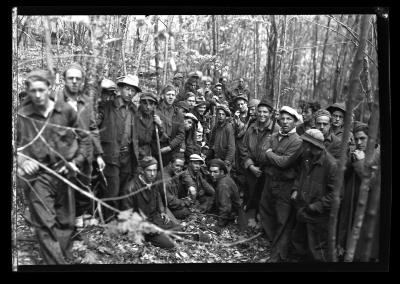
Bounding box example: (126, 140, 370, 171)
(259, 176, 295, 262)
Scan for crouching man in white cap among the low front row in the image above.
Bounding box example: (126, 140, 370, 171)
(188, 154, 215, 213)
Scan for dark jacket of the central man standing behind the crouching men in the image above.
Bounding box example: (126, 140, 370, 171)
(207, 121, 235, 164)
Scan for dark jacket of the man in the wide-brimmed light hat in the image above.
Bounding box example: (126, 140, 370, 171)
(98, 97, 139, 166)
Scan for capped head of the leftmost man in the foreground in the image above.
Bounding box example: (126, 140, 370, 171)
(25, 70, 53, 108)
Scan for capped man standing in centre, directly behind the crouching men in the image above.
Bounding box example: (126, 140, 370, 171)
(207, 105, 235, 169)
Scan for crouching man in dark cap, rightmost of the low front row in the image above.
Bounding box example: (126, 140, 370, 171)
(209, 159, 241, 227)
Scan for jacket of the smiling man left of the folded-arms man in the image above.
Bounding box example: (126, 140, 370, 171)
(239, 120, 279, 169)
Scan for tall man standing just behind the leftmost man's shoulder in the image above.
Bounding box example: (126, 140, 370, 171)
(56, 63, 105, 227)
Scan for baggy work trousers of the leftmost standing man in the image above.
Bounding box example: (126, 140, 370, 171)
(27, 173, 75, 264)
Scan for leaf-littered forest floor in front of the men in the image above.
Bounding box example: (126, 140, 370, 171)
(16, 200, 269, 265)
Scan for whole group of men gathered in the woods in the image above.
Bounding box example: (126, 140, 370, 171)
(17, 63, 379, 264)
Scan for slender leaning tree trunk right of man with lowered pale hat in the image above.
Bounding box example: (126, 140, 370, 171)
(329, 15, 370, 262)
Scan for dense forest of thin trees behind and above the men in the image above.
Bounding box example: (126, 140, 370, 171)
(13, 15, 378, 118)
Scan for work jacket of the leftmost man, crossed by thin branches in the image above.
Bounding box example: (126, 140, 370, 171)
(17, 100, 91, 169)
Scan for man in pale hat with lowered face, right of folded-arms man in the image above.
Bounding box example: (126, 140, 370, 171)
(291, 129, 337, 262)
